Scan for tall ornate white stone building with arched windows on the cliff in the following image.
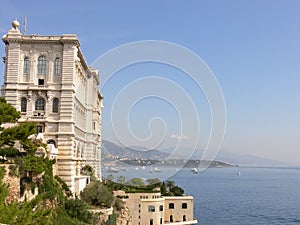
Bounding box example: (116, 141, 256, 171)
(2, 21, 102, 193)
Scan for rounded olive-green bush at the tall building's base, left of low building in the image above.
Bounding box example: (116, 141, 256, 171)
(80, 181, 114, 207)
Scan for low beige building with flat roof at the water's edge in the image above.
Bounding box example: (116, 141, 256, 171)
(114, 190, 198, 225)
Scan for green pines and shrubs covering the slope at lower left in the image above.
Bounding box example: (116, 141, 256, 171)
(0, 98, 94, 225)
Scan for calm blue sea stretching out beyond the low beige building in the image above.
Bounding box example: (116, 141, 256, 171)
(103, 167, 300, 225)
